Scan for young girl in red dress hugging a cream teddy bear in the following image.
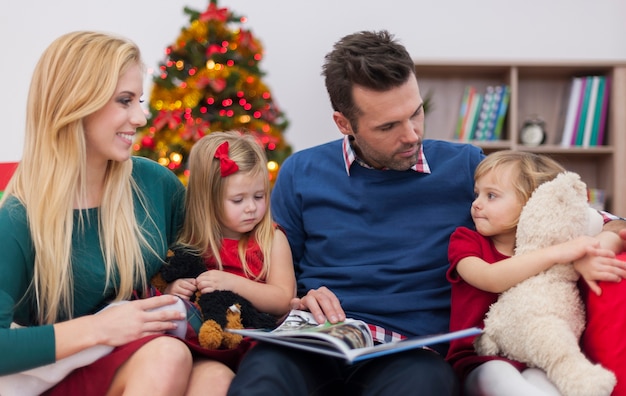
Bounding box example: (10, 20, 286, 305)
(447, 151, 626, 396)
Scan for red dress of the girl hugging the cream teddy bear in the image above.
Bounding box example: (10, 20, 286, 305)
(446, 227, 526, 381)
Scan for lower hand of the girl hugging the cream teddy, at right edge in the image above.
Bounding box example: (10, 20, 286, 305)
(574, 247, 626, 295)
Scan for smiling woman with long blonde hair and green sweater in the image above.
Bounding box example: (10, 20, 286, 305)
(0, 32, 233, 395)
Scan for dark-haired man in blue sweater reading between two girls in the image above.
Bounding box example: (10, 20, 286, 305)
(229, 31, 624, 396)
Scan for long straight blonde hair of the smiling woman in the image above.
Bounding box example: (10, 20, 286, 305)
(3, 31, 153, 323)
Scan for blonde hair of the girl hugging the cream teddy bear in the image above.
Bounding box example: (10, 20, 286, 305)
(474, 150, 565, 203)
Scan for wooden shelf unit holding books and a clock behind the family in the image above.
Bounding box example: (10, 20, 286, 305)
(415, 60, 626, 217)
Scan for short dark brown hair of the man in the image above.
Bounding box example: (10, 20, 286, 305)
(322, 30, 415, 130)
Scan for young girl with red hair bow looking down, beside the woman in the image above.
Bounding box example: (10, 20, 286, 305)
(166, 132, 296, 378)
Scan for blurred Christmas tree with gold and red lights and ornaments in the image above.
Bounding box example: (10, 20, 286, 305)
(134, 0, 291, 182)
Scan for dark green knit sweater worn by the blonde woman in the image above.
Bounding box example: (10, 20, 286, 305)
(0, 157, 185, 375)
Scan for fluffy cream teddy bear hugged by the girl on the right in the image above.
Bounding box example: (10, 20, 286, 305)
(474, 172, 616, 396)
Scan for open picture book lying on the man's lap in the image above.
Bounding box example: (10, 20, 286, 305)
(227, 310, 481, 363)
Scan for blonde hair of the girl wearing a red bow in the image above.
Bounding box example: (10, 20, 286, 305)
(178, 131, 274, 280)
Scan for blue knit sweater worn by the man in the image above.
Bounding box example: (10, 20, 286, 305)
(272, 140, 484, 348)
